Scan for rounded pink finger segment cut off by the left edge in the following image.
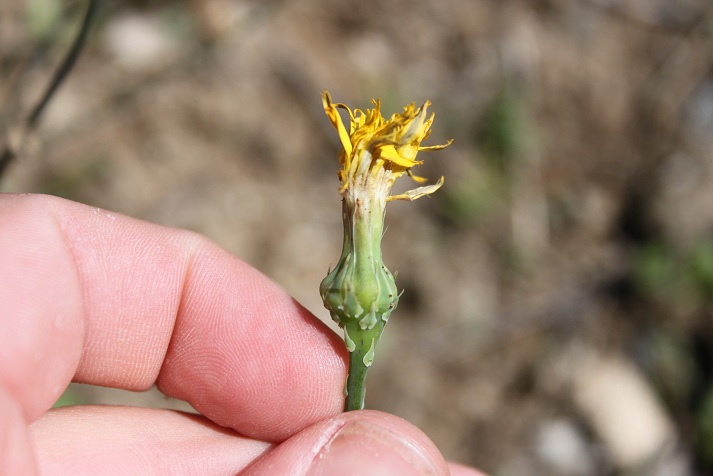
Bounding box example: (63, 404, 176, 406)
(0, 194, 85, 420)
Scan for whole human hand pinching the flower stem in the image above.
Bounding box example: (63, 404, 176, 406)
(0, 194, 480, 476)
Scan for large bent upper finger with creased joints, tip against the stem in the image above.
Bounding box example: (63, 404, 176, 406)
(0, 195, 346, 440)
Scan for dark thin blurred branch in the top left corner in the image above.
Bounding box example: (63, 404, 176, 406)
(0, 0, 99, 177)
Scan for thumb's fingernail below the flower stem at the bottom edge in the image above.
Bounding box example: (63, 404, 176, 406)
(308, 421, 439, 476)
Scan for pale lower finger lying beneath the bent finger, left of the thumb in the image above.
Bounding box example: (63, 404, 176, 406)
(29, 406, 270, 476)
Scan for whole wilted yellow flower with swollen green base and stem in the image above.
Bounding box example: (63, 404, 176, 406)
(319, 91, 451, 410)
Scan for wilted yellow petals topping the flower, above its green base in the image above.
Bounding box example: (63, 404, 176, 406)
(322, 91, 452, 201)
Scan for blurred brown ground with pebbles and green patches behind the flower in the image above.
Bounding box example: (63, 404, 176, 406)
(0, 0, 713, 476)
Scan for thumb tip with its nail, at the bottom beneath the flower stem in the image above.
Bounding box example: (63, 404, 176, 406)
(243, 410, 448, 476)
